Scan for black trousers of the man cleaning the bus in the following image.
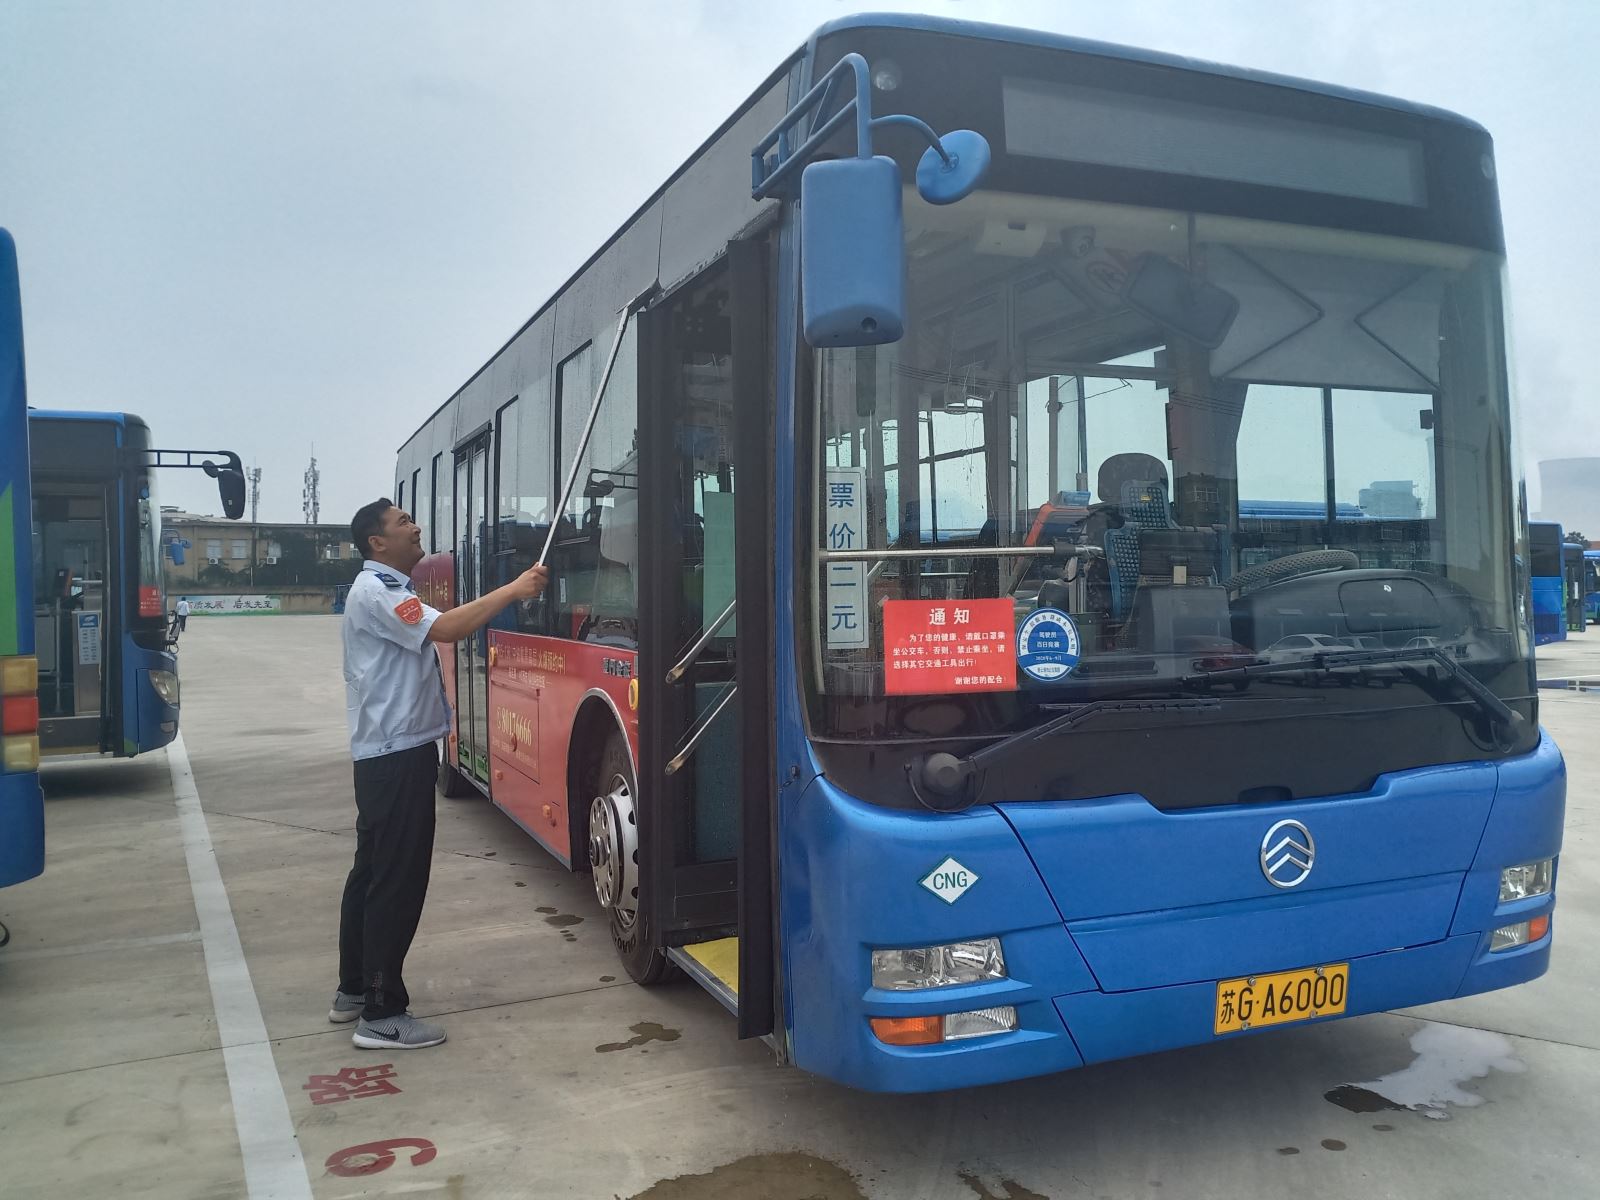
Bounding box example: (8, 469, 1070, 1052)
(339, 742, 438, 1021)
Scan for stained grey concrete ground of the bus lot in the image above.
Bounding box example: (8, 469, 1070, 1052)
(0, 618, 1600, 1200)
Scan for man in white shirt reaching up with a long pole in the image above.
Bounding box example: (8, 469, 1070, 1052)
(328, 499, 549, 1050)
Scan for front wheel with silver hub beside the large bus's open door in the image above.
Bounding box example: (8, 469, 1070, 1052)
(589, 730, 670, 984)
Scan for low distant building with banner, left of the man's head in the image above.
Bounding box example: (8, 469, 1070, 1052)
(162, 509, 362, 613)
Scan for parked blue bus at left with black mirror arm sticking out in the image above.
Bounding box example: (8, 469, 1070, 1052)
(27, 410, 243, 758)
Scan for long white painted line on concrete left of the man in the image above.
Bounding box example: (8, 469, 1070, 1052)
(166, 734, 310, 1200)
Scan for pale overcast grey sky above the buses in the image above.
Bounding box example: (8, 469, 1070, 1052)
(0, 0, 1600, 522)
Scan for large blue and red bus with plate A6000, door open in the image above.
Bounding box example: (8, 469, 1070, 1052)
(390, 16, 1565, 1091)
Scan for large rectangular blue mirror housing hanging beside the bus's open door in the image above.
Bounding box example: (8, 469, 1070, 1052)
(800, 155, 906, 349)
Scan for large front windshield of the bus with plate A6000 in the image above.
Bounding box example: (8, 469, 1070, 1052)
(808, 192, 1528, 736)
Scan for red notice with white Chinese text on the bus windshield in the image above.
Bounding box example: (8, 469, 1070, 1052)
(883, 600, 1016, 696)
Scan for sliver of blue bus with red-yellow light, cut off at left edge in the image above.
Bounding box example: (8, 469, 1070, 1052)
(0, 229, 45, 908)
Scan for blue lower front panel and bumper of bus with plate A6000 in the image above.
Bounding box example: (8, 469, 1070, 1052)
(781, 741, 1565, 1091)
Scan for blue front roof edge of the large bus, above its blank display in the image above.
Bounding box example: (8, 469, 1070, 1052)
(811, 13, 1488, 133)
